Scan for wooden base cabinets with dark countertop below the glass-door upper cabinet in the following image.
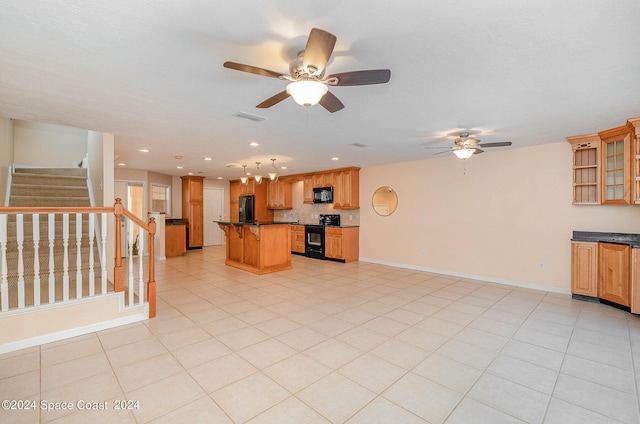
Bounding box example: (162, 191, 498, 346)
(571, 232, 640, 314)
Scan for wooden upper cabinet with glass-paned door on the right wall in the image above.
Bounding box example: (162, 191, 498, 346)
(567, 118, 640, 205)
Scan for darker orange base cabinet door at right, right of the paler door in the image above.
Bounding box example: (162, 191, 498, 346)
(598, 243, 631, 306)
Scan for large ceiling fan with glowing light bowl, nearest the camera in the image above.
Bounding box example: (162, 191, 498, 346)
(224, 28, 391, 113)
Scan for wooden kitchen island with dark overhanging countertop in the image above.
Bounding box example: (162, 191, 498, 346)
(216, 221, 291, 274)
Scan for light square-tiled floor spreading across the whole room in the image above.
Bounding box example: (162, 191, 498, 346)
(0, 247, 640, 424)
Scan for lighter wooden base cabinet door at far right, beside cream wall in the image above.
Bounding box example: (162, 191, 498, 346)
(571, 241, 598, 297)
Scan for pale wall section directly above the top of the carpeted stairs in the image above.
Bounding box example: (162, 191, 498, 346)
(13, 120, 87, 168)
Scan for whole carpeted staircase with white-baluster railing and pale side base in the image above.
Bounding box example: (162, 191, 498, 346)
(0, 168, 156, 353)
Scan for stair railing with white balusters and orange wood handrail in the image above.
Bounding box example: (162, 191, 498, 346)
(0, 199, 155, 318)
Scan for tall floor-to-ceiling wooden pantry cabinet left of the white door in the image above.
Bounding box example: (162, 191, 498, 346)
(180, 176, 204, 249)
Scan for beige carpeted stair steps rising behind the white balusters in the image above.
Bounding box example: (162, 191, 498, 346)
(7, 168, 104, 310)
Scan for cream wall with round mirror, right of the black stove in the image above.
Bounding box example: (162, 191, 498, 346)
(360, 142, 640, 292)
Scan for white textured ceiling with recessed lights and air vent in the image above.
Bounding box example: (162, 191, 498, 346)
(0, 0, 640, 178)
